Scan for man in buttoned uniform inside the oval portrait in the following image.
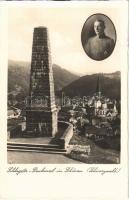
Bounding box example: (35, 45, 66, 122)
(84, 20, 115, 60)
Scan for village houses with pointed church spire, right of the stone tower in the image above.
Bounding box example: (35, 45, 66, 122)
(59, 75, 120, 140)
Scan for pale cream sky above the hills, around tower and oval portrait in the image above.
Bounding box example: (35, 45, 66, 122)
(8, 3, 125, 74)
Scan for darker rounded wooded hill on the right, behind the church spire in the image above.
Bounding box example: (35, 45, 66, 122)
(63, 71, 121, 99)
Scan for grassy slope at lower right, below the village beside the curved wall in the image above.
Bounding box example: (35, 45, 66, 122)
(68, 133, 120, 164)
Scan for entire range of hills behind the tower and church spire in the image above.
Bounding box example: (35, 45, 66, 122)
(8, 61, 121, 99)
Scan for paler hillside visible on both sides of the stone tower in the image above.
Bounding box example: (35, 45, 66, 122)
(8, 60, 79, 94)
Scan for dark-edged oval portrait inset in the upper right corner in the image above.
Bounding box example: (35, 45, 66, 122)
(81, 13, 116, 61)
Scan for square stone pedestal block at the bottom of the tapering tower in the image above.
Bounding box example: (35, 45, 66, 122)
(26, 110, 58, 137)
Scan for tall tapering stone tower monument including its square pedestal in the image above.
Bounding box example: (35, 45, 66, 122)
(26, 27, 57, 137)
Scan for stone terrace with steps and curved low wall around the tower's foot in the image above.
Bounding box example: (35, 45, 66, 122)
(8, 122, 73, 151)
